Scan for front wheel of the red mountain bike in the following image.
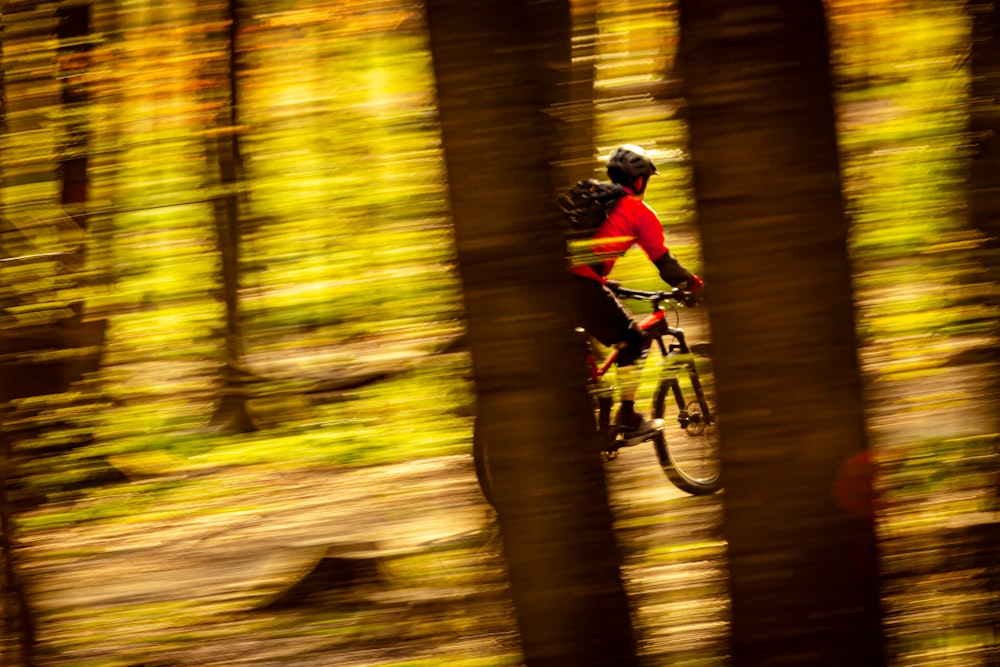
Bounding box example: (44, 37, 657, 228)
(653, 375, 722, 496)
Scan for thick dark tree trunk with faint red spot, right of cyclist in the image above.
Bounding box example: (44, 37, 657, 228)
(680, 0, 884, 667)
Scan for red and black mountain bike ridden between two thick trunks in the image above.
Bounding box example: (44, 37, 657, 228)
(472, 281, 722, 504)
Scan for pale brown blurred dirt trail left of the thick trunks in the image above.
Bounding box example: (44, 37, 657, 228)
(27, 457, 485, 611)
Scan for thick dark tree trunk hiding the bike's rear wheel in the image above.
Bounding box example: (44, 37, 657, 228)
(427, 0, 636, 667)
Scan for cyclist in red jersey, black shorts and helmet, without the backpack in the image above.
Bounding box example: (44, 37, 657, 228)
(570, 144, 703, 441)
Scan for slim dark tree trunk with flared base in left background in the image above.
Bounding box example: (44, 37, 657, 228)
(205, 0, 257, 433)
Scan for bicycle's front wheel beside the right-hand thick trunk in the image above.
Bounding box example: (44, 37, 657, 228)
(653, 360, 722, 496)
